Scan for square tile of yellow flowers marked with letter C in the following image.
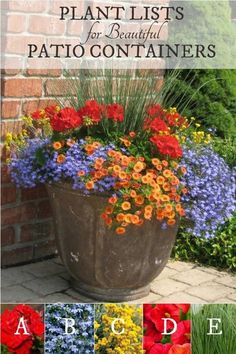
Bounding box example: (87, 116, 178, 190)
(94, 304, 143, 354)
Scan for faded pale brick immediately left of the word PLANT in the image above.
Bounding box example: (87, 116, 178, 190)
(28, 15, 66, 35)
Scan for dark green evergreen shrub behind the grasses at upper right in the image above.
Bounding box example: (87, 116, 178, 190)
(167, 70, 236, 139)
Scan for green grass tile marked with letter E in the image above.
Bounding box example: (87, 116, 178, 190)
(192, 304, 236, 354)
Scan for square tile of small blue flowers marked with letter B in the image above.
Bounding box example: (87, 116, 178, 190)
(45, 304, 94, 354)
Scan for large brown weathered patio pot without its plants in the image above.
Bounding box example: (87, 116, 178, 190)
(48, 184, 177, 302)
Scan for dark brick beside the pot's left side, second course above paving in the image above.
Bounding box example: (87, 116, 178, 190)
(20, 222, 54, 242)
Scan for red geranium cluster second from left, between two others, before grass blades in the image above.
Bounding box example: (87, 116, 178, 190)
(78, 100, 102, 125)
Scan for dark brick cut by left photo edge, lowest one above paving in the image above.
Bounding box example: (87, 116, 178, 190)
(1, 246, 33, 266)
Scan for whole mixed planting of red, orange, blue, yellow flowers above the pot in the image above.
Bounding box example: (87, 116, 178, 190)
(6, 71, 236, 237)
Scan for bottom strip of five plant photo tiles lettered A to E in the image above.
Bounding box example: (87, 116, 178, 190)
(1, 303, 236, 354)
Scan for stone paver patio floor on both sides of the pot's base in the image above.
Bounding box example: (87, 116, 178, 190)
(1, 258, 236, 303)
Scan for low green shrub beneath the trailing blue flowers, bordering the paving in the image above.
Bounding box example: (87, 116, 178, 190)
(172, 214, 236, 271)
